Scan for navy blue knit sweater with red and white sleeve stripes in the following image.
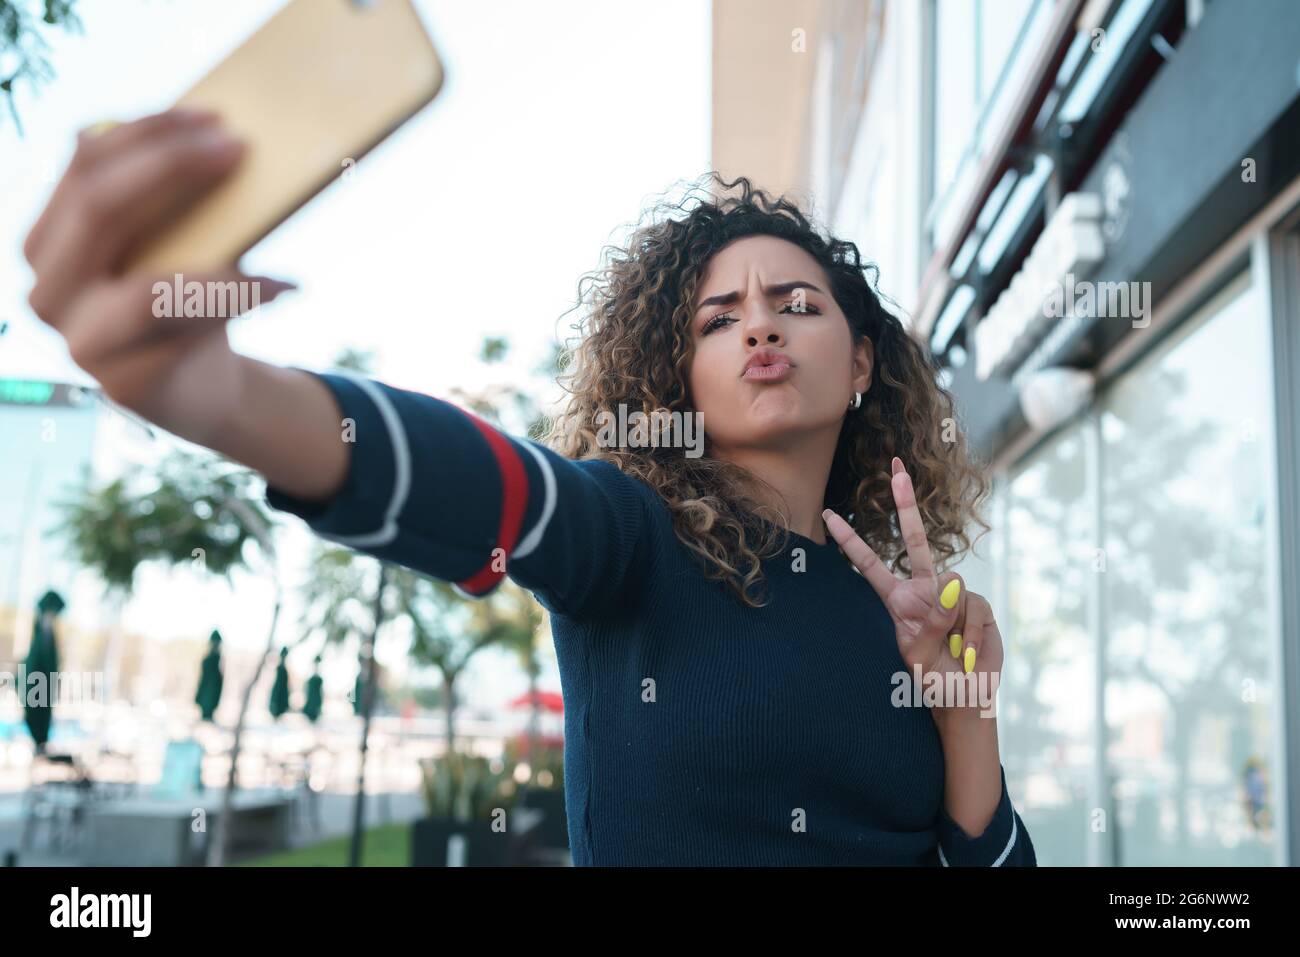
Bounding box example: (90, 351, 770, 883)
(267, 374, 1036, 866)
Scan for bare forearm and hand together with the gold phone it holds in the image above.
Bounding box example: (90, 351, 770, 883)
(23, 0, 442, 497)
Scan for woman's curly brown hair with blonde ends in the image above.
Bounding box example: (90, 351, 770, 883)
(543, 172, 988, 607)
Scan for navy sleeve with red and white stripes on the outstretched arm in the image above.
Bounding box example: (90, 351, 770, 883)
(267, 374, 647, 616)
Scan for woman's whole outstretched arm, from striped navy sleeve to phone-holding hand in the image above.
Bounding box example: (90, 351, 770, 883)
(23, 111, 655, 615)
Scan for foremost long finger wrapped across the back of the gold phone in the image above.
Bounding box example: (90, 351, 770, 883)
(31, 129, 241, 322)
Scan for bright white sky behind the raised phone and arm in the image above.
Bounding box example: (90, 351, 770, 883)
(0, 0, 710, 712)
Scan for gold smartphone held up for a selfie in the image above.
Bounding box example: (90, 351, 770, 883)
(127, 0, 443, 273)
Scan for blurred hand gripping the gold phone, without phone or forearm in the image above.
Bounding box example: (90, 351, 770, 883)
(23, 109, 282, 434)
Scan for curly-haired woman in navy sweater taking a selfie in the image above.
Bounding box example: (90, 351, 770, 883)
(23, 111, 1036, 866)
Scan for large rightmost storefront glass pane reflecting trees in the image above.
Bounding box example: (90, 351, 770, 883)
(1101, 273, 1278, 866)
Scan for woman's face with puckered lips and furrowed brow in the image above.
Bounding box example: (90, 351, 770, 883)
(689, 235, 872, 451)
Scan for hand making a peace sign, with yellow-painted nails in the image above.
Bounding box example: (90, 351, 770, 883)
(822, 456, 1002, 713)
